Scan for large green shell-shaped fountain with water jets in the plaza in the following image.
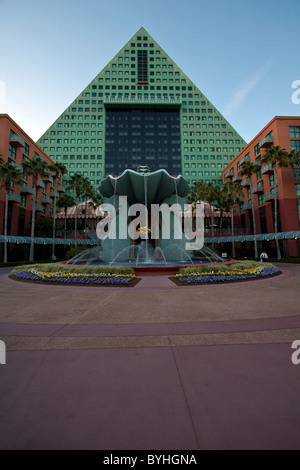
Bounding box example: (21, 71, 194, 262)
(68, 167, 224, 269)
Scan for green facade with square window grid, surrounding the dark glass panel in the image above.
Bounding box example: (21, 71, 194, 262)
(40, 28, 245, 187)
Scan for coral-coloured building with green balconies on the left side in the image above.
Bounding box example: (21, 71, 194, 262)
(0, 114, 64, 244)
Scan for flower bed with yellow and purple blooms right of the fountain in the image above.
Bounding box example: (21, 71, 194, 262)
(172, 265, 281, 285)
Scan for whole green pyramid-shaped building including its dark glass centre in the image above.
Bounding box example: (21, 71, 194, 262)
(37, 28, 246, 193)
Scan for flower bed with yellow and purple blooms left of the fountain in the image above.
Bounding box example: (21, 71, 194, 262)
(10, 267, 139, 286)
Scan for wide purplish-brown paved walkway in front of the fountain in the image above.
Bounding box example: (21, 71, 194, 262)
(0, 265, 300, 450)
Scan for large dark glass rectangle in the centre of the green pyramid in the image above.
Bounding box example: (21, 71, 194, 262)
(105, 108, 181, 175)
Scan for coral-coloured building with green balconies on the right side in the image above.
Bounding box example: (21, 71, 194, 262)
(223, 116, 300, 256)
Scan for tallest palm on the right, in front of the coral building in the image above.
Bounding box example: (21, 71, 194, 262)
(261, 145, 293, 260)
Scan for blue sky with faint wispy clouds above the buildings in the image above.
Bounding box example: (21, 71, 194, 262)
(0, 0, 300, 142)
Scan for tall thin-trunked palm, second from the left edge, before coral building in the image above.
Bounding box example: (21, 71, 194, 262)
(22, 157, 48, 261)
